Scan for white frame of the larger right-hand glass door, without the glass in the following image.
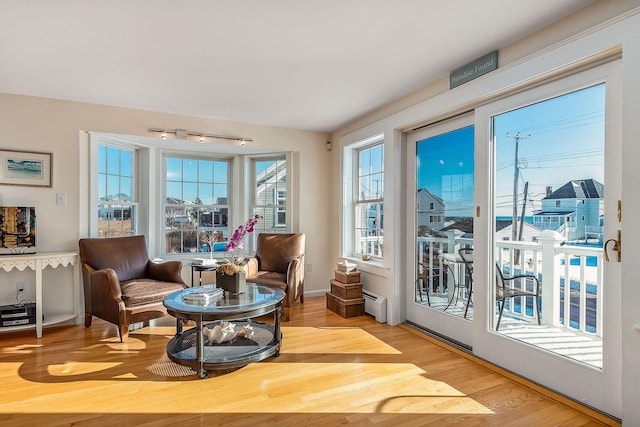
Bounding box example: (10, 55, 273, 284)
(473, 60, 624, 417)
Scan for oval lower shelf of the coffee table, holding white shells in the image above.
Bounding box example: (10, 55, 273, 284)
(167, 321, 281, 378)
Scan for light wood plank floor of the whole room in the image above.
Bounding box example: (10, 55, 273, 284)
(0, 298, 616, 427)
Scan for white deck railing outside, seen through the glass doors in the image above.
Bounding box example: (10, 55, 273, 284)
(416, 230, 604, 337)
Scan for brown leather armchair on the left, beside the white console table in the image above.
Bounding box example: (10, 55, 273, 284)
(79, 236, 187, 342)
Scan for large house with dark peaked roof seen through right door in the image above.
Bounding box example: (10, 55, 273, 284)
(533, 178, 604, 241)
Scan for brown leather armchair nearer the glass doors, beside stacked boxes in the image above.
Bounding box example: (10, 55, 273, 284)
(245, 233, 305, 320)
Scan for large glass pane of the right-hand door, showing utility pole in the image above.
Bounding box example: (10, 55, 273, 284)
(491, 84, 605, 368)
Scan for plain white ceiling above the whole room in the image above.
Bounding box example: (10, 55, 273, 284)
(0, 0, 591, 132)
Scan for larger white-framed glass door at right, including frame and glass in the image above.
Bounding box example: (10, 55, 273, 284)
(471, 63, 622, 416)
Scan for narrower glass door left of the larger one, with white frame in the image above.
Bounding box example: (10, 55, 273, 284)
(407, 115, 474, 347)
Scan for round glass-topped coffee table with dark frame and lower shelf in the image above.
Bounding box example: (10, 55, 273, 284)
(164, 284, 284, 378)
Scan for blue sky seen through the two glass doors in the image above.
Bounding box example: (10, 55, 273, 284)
(417, 84, 605, 216)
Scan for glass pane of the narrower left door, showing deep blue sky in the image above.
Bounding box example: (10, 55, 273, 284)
(415, 126, 474, 319)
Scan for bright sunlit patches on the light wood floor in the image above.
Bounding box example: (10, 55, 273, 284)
(0, 327, 493, 414)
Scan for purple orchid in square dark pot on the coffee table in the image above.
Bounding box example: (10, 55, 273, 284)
(216, 215, 262, 293)
